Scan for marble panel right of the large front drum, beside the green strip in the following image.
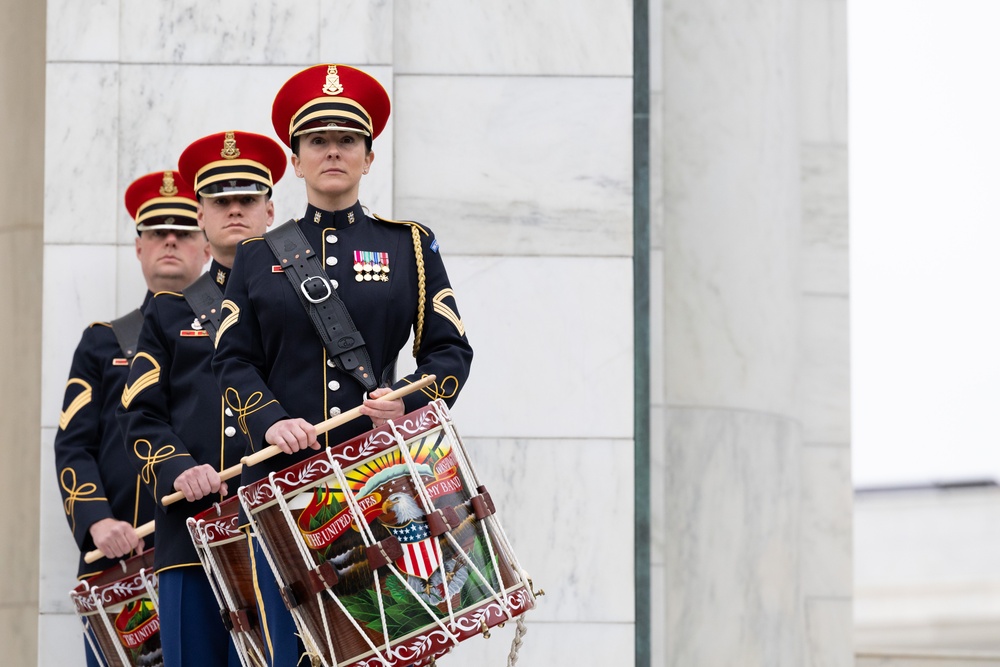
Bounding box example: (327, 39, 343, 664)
(455, 436, 635, 624)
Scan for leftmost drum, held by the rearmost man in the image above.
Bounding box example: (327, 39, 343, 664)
(69, 549, 163, 667)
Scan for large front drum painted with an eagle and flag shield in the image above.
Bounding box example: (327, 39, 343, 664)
(239, 400, 535, 667)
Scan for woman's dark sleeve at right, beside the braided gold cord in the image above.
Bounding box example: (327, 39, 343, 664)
(393, 233, 472, 412)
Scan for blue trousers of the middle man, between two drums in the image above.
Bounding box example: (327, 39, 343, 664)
(157, 567, 241, 667)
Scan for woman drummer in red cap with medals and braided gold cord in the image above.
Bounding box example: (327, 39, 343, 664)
(213, 65, 472, 665)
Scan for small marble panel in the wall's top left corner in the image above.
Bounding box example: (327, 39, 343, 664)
(40, 0, 121, 63)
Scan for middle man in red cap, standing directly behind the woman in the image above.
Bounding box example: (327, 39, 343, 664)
(117, 131, 285, 667)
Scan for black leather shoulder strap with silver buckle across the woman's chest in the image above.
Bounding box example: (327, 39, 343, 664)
(264, 220, 378, 391)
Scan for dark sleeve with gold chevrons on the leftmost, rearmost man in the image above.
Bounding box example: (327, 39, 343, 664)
(54, 324, 114, 551)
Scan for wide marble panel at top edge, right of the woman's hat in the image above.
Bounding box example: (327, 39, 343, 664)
(395, 0, 632, 76)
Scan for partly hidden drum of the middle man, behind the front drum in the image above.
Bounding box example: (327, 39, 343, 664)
(187, 496, 267, 667)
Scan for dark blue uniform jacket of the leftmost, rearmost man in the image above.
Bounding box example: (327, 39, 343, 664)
(54, 293, 153, 577)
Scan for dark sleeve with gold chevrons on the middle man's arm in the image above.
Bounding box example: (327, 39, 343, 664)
(116, 297, 198, 509)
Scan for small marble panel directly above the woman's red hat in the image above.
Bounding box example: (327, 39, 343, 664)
(318, 0, 396, 66)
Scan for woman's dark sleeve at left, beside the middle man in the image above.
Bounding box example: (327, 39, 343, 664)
(212, 241, 289, 452)
